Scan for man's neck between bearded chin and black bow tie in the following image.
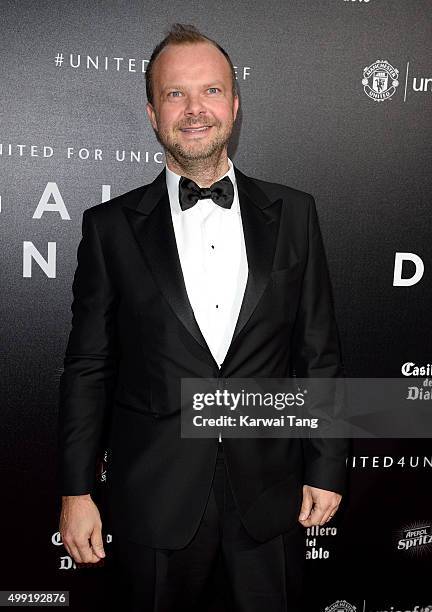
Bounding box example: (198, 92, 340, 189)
(165, 150, 229, 187)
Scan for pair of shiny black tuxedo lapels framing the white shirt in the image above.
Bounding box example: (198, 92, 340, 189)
(123, 168, 282, 365)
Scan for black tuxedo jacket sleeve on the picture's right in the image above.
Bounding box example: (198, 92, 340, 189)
(292, 196, 349, 494)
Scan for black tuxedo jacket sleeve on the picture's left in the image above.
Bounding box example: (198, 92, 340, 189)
(58, 210, 117, 495)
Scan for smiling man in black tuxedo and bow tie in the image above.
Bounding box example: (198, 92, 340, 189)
(59, 24, 347, 612)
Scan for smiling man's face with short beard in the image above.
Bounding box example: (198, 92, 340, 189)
(146, 42, 239, 161)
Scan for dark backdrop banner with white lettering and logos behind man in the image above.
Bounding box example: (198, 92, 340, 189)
(0, 0, 432, 612)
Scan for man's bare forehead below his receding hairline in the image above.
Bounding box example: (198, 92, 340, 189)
(154, 42, 231, 86)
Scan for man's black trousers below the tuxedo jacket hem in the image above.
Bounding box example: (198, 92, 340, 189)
(108, 444, 305, 612)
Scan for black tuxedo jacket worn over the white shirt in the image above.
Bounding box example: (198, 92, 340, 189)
(59, 168, 347, 549)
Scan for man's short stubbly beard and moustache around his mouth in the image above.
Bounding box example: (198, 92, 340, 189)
(156, 118, 234, 163)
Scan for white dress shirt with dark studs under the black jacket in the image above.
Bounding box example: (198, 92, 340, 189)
(165, 158, 248, 367)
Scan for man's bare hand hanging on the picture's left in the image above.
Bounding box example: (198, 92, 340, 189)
(59, 493, 105, 563)
